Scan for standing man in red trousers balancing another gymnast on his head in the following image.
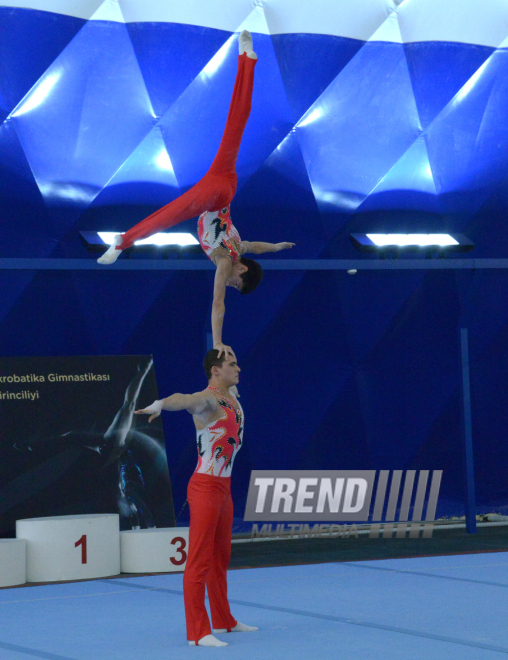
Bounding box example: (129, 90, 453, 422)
(136, 349, 257, 646)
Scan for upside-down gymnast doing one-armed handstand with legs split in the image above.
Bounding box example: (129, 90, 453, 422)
(98, 30, 294, 355)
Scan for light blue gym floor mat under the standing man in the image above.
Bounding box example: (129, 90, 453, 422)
(0, 552, 508, 660)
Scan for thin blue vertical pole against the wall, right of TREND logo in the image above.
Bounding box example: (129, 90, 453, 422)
(460, 328, 477, 534)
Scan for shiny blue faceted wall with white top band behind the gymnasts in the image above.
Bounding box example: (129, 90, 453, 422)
(0, 0, 508, 518)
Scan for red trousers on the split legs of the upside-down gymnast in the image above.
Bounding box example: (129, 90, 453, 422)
(118, 53, 257, 250)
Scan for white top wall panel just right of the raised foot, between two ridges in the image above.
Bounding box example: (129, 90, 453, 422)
(263, 0, 396, 41)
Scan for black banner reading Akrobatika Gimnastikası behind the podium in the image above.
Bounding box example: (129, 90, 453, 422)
(0, 356, 175, 536)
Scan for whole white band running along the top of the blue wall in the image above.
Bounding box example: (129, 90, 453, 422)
(0, 0, 508, 47)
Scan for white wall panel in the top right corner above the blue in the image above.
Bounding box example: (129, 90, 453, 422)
(398, 0, 508, 48)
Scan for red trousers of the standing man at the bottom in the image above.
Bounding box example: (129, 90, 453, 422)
(183, 472, 237, 644)
